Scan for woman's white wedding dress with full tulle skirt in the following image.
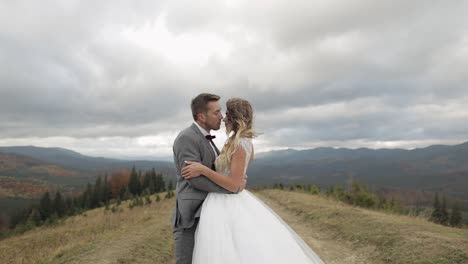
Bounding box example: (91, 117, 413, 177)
(192, 138, 323, 264)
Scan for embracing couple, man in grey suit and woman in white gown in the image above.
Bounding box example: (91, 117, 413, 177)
(171, 93, 323, 264)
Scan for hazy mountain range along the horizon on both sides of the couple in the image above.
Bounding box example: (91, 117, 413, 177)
(0, 142, 468, 211)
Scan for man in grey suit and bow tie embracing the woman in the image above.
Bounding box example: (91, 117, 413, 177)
(171, 93, 246, 264)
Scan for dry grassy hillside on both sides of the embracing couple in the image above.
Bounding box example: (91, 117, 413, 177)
(0, 190, 468, 263)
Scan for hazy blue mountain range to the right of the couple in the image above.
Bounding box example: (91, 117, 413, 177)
(248, 142, 468, 203)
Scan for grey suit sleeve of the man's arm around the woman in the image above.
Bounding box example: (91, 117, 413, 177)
(174, 136, 233, 194)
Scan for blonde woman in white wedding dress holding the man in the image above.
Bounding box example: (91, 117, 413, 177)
(182, 98, 323, 264)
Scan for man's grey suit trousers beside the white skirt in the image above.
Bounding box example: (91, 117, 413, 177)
(173, 218, 199, 264)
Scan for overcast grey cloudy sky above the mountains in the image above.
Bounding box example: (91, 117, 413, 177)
(0, 0, 468, 159)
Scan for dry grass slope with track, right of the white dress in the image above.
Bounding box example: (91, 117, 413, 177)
(257, 190, 468, 263)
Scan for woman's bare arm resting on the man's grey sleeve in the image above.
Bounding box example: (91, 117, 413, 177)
(182, 147, 246, 192)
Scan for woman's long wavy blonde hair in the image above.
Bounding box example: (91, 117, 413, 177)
(216, 98, 256, 170)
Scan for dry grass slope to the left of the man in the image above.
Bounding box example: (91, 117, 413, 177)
(0, 194, 174, 263)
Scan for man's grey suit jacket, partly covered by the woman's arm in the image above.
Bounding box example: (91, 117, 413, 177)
(171, 124, 232, 229)
